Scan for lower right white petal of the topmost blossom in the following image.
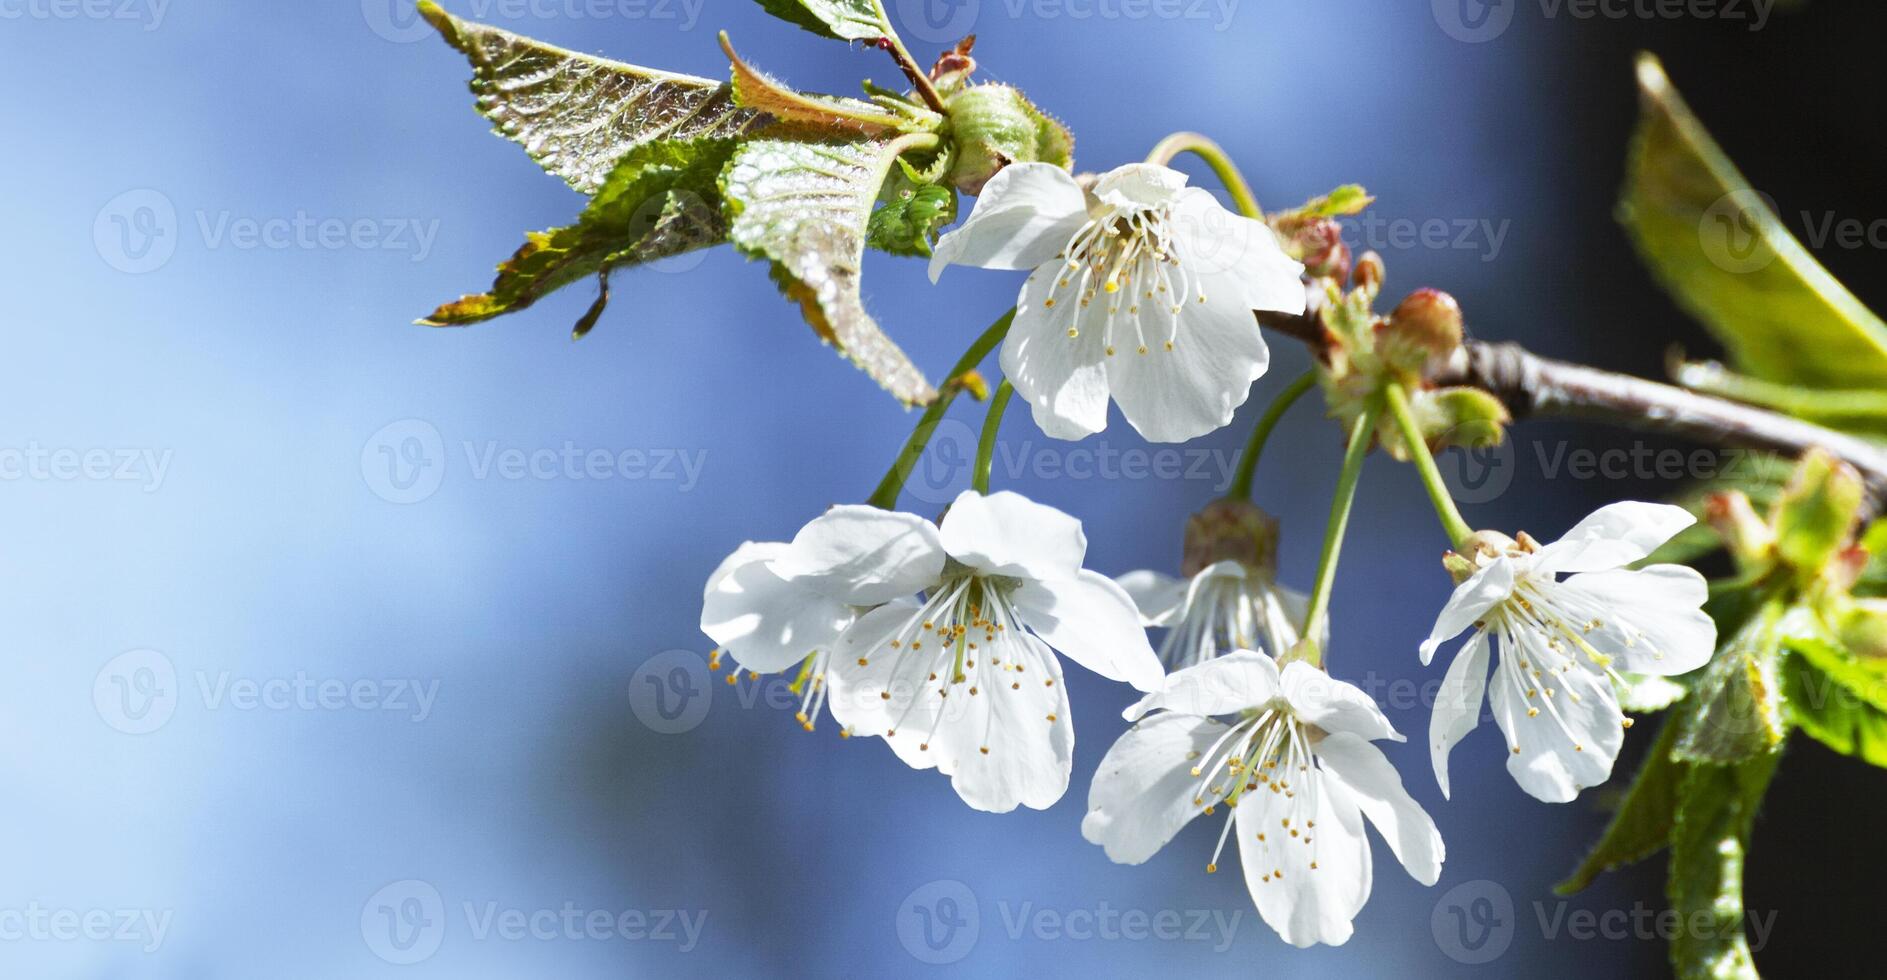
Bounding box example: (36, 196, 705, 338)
(1096, 264, 1272, 442)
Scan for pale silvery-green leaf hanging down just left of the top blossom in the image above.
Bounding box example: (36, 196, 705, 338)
(721, 138, 936, 404)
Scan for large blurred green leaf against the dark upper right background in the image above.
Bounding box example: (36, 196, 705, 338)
(1619, 55, 1887, 389)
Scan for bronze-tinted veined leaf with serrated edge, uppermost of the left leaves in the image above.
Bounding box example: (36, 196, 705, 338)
(419, 0, 772, 194)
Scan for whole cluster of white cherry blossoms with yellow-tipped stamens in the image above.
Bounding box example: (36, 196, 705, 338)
(702, 164, 1715, 946)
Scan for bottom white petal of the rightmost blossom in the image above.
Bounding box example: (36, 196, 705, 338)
(1489, 648, 1625, 803)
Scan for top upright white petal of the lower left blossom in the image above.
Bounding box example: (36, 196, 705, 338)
(942, 491, 1087, 578)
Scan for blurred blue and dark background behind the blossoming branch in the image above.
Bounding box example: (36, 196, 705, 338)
(0, 0, 1887, 978)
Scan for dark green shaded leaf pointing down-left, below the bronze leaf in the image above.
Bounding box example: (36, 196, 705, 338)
(419, 140, 736, 338)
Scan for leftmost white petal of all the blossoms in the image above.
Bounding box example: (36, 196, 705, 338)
(702, 542, 853, 674)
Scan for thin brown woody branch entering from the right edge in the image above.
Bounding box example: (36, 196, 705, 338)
(1259, 313, 1887, 504)
